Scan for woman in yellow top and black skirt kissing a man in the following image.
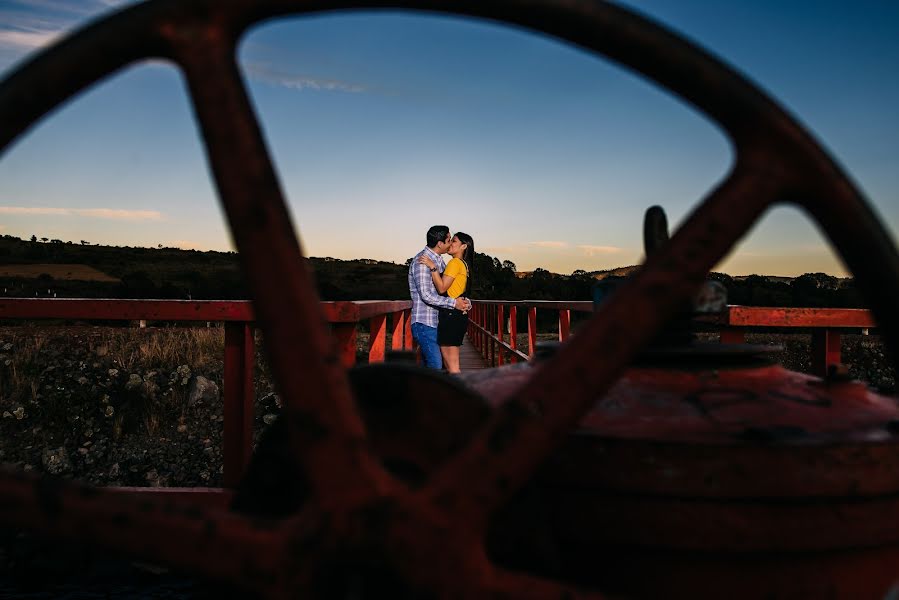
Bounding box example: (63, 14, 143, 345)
(419, 231, 474, 373)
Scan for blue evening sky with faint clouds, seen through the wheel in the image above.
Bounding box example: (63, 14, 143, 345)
(0, 0, 899, 275)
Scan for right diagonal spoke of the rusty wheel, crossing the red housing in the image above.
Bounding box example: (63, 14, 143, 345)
(421, 168, 779, 523)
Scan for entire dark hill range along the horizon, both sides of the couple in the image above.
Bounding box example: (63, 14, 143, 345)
(0, 235, 864, 308)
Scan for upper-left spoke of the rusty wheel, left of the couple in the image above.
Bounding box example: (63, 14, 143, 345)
(171, 29, 391, 505)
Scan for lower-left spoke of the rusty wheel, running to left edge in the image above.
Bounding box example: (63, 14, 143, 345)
(0, 471, 285, 589)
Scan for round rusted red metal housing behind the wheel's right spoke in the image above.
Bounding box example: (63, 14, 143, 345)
(463, 356, 899, 598)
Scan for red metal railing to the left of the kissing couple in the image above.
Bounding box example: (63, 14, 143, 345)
(0, 298, 412, 487)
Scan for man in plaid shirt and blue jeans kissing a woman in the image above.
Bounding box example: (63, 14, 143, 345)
(409, 225, 471, 369)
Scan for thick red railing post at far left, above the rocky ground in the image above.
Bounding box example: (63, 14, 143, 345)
(222, 322, 255, 488)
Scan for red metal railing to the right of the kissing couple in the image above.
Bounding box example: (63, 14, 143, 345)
(469, 300, 877, 377)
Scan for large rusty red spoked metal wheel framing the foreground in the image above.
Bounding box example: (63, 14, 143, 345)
(0, 0, 899, 598)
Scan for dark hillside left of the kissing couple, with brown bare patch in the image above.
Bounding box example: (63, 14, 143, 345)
(0, 235, 409, 300)
